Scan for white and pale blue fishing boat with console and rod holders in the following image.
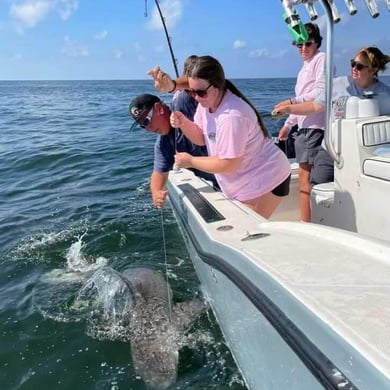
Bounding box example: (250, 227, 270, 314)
(168, 0, 390, 390)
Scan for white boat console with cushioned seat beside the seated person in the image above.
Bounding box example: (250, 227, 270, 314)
(311, 112, 390, 241)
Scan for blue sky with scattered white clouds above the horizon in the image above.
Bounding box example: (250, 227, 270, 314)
(0, 0, 390, 80)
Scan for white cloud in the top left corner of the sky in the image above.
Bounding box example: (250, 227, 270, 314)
(9, 0, 78, 28)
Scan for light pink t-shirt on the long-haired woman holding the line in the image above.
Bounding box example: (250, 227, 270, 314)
(194, 91, 291, 201)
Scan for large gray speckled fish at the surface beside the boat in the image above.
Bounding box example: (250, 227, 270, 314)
(121, 268, 205, 390)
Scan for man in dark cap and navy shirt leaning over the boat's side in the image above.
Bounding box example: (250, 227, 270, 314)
(129, 91, 218, 207)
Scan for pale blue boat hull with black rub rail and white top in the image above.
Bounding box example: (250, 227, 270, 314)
(168, 170, 390, 390)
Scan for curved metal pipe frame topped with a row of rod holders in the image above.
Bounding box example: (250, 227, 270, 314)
(280, 0, 390, 168)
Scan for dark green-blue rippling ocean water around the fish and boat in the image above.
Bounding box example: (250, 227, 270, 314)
(0, 79, 294, 390)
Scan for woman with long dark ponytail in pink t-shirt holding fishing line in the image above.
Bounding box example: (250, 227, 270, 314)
(171, 56, 291, 218)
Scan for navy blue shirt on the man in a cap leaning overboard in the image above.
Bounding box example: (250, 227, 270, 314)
(153, 91, 219, 188)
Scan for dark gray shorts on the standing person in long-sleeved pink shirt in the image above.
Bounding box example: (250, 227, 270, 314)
(295, 129, 324, 165)
